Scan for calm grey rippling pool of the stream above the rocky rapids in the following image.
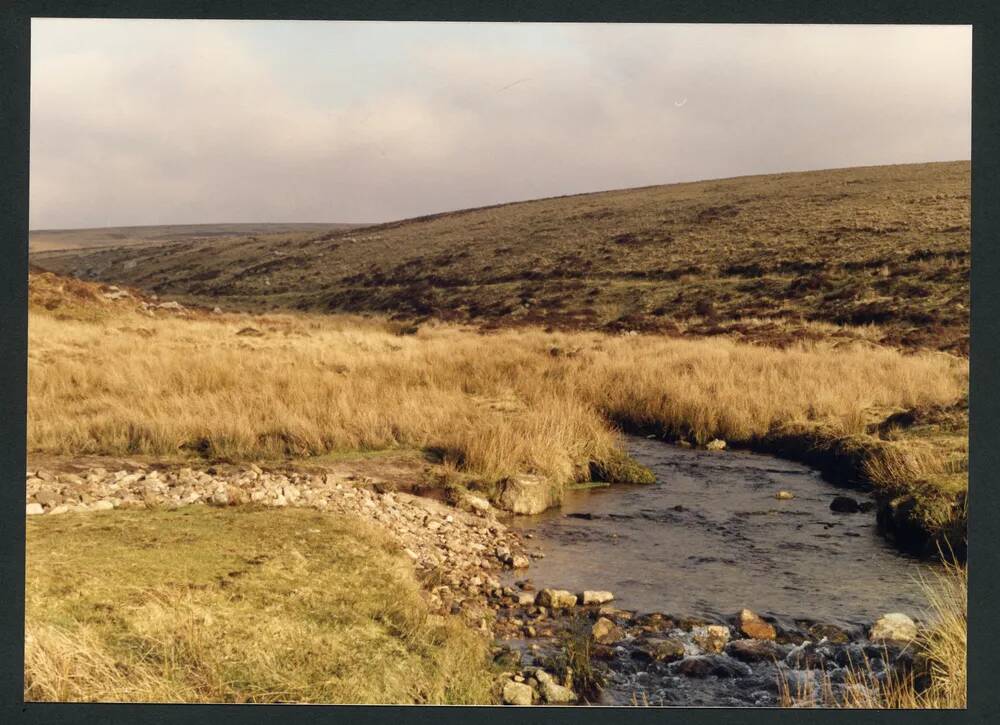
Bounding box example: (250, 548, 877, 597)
(513, 438, 925, 626)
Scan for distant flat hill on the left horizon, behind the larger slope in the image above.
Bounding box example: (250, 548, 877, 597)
(28, 223, 361, 252)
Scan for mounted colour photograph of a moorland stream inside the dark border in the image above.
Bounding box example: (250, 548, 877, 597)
(25, 18, 979, 714)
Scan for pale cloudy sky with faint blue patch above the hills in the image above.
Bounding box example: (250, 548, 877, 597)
(29, 19, 972, 229)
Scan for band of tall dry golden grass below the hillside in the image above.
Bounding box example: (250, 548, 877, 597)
(28, 300, 968, 483)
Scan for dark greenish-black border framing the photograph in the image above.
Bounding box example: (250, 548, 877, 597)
(0, 0, 1000, 725)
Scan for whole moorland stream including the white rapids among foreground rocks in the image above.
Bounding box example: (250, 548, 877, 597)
(511, 437, 928, 705)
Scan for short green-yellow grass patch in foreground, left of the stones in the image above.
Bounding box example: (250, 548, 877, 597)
(24, 507, 492, 703)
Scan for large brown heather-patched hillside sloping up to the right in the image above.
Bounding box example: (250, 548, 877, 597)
(32, 162, 970, 353)
